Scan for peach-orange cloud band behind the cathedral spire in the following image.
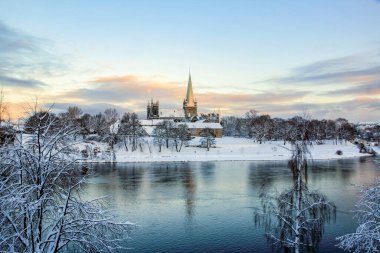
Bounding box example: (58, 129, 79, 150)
(62, 76, 309, 111)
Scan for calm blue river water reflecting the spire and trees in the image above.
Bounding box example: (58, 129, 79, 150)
(81, 158, 380, 252)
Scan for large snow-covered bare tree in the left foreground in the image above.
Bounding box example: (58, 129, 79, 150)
(0, 106, 132, 252)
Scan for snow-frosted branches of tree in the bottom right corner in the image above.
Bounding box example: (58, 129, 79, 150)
(337, 179, 380, 253)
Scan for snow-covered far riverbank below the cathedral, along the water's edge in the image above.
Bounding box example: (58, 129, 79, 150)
(78, 137, 368, 162)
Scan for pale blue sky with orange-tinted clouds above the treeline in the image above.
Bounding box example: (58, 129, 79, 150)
(0, 0, 380, 122)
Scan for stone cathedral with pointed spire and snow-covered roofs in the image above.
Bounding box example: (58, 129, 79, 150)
(145, 73, 223, 137)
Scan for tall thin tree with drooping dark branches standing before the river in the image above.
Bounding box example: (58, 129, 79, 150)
(255, 141, 335, 253)
